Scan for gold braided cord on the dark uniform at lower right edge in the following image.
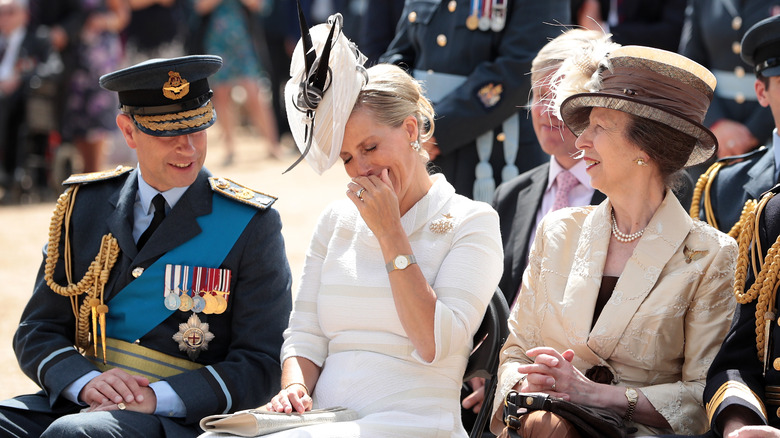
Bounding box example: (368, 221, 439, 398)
(734, 192, 780, 361)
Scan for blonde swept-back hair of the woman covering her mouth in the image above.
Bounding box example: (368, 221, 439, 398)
(352, 64, 434, 148)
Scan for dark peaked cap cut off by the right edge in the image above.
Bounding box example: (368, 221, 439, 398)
(741, 15, 780, 78)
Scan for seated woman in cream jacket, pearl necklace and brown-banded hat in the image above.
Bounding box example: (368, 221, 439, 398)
(491, 46, 737, 438)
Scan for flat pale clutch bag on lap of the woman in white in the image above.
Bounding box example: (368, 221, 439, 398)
(200, 406, 358, 437)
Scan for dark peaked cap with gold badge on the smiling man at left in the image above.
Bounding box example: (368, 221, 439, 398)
(100, 55, 222, 137)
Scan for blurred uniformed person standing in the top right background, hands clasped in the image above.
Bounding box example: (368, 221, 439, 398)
(680, 0, 780, 181)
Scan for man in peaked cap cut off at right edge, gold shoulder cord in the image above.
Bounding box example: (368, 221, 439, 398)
(691, 12, 780, 237)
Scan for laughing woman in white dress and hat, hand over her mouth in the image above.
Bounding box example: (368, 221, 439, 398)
(267, 13, 503, 437)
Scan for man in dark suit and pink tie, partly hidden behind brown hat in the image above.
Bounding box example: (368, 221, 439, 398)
(493, 29, 608, 306)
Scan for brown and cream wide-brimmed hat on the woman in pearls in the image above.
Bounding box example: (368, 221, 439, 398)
(558, 46, 718, 167)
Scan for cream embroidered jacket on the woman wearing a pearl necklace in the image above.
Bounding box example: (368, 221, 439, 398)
(491, 191, 737, 434)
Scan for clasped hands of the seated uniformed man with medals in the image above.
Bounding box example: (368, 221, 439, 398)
(79, 368, 157, 414)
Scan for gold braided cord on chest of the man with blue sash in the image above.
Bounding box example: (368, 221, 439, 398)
(43, 185, 119, 363)
